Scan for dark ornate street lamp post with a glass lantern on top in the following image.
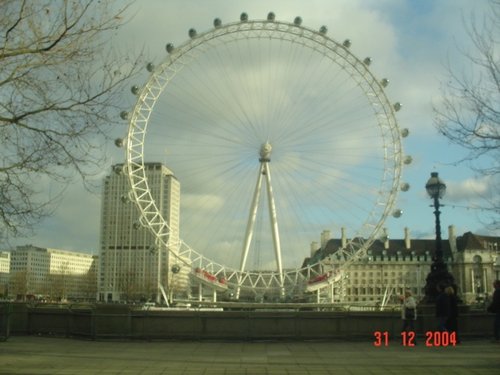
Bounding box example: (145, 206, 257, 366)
(425, 172, 455, 302)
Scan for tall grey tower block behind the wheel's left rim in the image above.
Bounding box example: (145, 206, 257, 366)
(98, 163, 189, 302)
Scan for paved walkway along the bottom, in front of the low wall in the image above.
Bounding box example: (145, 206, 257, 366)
(0, 336, 500, 375)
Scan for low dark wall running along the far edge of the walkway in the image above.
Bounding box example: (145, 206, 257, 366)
(0, 302, 493, 342)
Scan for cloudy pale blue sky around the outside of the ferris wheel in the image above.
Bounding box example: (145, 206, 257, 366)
(4, 0, 500, 270)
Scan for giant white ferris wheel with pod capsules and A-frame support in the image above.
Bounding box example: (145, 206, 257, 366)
(120, 13, 411, 297)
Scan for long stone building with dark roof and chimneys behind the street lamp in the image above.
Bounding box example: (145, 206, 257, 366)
(303, 226, 500, 305)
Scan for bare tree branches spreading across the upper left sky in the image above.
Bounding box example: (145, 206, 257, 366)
(0, 0, 139, 237)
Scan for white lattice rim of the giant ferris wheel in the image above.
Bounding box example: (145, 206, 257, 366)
(126, 15, 403, 296)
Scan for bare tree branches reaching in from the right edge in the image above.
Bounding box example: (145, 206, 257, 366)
(434, 0, 500, 226)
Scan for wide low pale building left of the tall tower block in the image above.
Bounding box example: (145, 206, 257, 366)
(8, 245, 97, 301)
